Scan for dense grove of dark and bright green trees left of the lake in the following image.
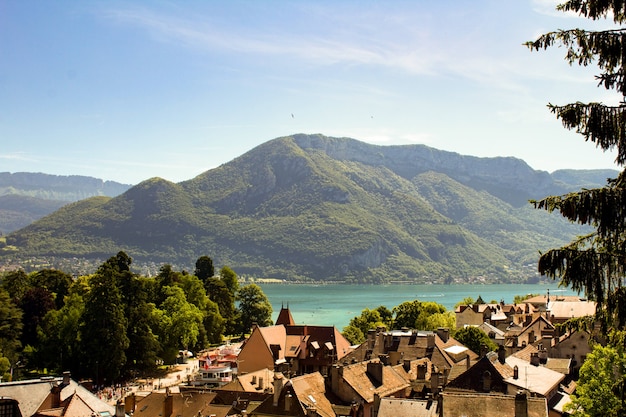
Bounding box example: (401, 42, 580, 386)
(0, 252, 272, 384)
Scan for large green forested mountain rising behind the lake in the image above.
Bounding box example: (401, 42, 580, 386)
(0, 135, 617, 282)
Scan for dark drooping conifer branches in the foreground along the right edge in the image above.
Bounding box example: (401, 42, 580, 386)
(526, 0, 626, 329)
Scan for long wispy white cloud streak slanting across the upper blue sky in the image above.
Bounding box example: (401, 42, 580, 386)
(103, 8, 442, 73)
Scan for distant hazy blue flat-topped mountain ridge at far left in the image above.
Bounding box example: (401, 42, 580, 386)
(0, 172, 131, 234)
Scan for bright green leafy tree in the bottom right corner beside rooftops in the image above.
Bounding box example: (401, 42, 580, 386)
(567, 345, 626, 417)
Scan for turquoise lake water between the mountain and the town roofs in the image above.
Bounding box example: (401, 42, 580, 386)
(259, 283, 577, 330)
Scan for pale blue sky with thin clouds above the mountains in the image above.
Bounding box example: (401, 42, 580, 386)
(0, 0, 620, 184)
